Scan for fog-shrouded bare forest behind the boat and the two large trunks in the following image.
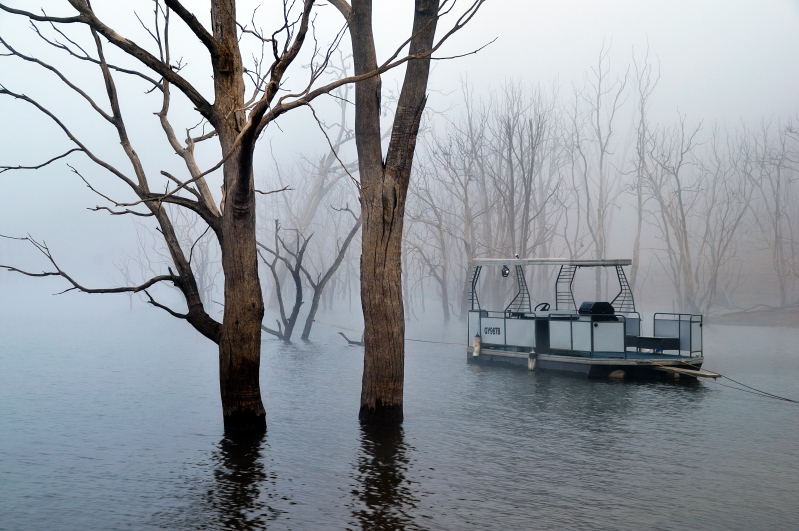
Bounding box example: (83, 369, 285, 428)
(252, 55, 799, 337)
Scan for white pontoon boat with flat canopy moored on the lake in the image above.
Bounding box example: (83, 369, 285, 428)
(467, 258, 712, 378)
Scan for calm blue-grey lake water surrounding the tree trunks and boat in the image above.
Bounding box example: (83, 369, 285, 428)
(0, 303, 799, 530)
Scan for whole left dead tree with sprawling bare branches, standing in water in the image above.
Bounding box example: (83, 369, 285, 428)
(0, 0, 456, 432)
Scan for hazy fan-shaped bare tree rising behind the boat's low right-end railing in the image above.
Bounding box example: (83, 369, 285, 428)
(646, 117, 750, 313)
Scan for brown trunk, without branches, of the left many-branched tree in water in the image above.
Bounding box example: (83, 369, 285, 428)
(211, 0, 266, 432)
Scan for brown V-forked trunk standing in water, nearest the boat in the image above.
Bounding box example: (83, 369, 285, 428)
(350, 0, 439, 424)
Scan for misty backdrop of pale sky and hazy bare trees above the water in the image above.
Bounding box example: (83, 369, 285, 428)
(0, 1, 799, 335)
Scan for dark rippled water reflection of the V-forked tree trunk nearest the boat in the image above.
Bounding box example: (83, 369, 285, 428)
(353, 426, 418, 529)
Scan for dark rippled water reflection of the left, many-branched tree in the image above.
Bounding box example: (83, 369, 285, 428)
(207, 435, 279, 529)
